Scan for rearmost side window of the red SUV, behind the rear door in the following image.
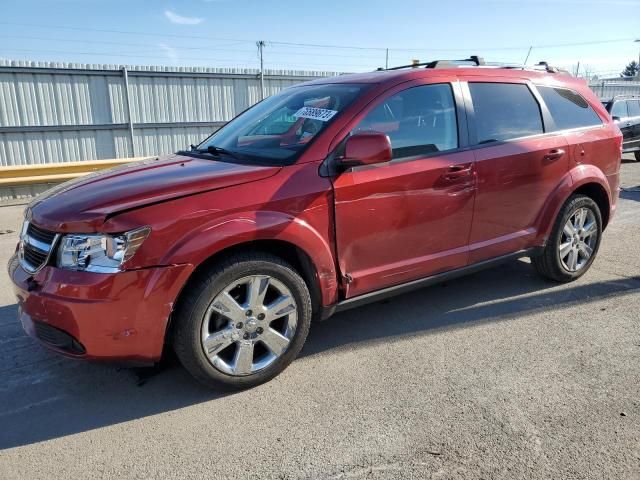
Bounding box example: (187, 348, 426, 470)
(538, 87, 602, 130)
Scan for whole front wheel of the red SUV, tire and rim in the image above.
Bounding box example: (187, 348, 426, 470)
(173, 254, 311, 389)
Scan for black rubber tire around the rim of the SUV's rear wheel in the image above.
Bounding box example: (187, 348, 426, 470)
(531, 195, 602, 283)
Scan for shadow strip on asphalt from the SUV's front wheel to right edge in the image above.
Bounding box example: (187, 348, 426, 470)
(303, 261, 640, 355)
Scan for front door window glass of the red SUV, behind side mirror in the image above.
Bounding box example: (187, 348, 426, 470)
(351, 84, 458, 159)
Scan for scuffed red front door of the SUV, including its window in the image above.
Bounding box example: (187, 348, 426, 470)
(333, 82, 475, 298)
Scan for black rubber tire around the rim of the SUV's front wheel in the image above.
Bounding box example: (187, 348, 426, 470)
(173, 253, 312, 390)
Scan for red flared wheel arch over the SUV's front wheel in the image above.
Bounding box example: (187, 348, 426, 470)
(161, 210, 338, 305)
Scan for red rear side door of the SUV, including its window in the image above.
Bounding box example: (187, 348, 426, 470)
(465, 76, 569, 263)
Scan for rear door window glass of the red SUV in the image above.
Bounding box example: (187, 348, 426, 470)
(469, 82, 544, 143)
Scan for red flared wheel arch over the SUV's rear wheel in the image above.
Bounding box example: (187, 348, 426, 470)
(536, 165, 613, 245)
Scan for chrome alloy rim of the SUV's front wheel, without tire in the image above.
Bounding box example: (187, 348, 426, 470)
(201, 275, 298, 376)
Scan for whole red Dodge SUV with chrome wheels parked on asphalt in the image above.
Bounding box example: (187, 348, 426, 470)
(9, 58, 622, 388)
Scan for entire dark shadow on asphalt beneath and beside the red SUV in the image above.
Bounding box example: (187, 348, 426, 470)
(0, 261, 640, 449)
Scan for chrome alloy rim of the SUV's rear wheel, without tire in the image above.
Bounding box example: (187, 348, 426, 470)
(558, 207, 598, 272)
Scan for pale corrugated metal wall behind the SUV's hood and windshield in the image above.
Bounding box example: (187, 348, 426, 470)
(0, 61, 337, 166)
